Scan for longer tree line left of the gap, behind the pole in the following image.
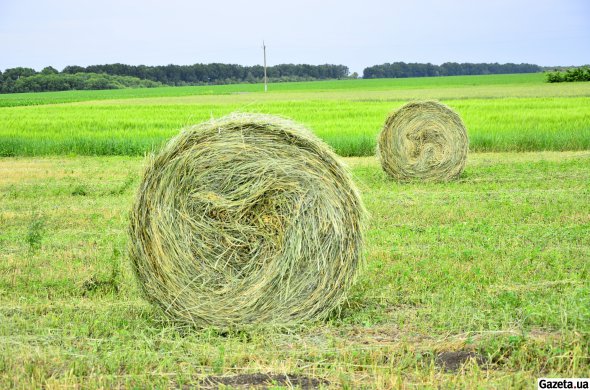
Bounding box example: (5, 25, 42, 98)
(0, 63, 349, 93)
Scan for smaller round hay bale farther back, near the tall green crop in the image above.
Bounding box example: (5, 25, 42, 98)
(377, 101, 469, 181)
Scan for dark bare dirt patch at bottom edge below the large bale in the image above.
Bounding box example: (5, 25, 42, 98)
(199, 373, 329, 389)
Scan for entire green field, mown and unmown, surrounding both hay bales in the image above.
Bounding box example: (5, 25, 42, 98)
(0, 74, 590, 389)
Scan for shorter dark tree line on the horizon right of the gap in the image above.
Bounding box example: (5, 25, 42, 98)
(363, 62, 543, 79)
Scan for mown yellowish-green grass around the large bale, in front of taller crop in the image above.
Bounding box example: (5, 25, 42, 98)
(0, 151, 590, 388)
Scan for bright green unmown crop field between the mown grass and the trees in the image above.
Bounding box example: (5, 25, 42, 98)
(0, 74, 590, 156)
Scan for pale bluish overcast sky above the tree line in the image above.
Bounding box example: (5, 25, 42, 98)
(0, 0, 590, 73)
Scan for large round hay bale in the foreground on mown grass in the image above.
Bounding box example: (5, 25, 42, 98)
(129, 114, 365, 328)
